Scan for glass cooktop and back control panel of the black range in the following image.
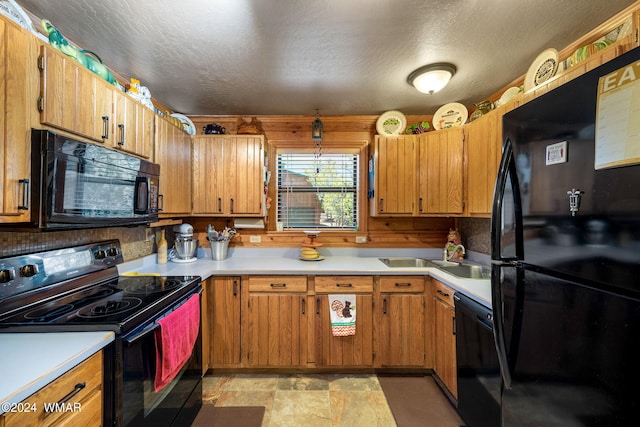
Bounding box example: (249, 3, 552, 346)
(0, 240, 200, 334)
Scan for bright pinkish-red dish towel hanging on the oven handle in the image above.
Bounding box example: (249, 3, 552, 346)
(154, 294, 200, 392)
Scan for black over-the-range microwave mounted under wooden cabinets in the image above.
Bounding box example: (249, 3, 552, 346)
(3, 129, 160, 230)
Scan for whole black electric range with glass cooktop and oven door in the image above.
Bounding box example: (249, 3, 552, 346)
(0, 240, 202, 427)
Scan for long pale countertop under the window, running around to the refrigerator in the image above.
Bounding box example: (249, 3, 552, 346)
(118, 248, 491, 307)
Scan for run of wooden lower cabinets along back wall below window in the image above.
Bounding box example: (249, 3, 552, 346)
(202, 275, 434, 370)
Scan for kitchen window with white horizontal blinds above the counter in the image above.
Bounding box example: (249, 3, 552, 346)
(276, 148, 360, 230)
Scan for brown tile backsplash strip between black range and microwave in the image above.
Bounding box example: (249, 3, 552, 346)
(0, 226, 154, 261)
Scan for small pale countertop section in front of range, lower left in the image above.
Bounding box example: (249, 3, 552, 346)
(0, 331, 114, 415)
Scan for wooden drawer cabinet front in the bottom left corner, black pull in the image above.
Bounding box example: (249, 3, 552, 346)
(4, 351, 102, 427)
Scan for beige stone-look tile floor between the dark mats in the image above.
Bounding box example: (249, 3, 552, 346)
(203, 374, 396, 427)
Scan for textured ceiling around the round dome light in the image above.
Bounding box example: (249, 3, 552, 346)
(17, 0, 633, 115)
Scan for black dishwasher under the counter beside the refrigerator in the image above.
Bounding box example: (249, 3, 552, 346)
(453, 292, 501, 427)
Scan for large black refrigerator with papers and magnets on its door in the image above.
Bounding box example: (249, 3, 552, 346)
(491, 48, 640, 427)
